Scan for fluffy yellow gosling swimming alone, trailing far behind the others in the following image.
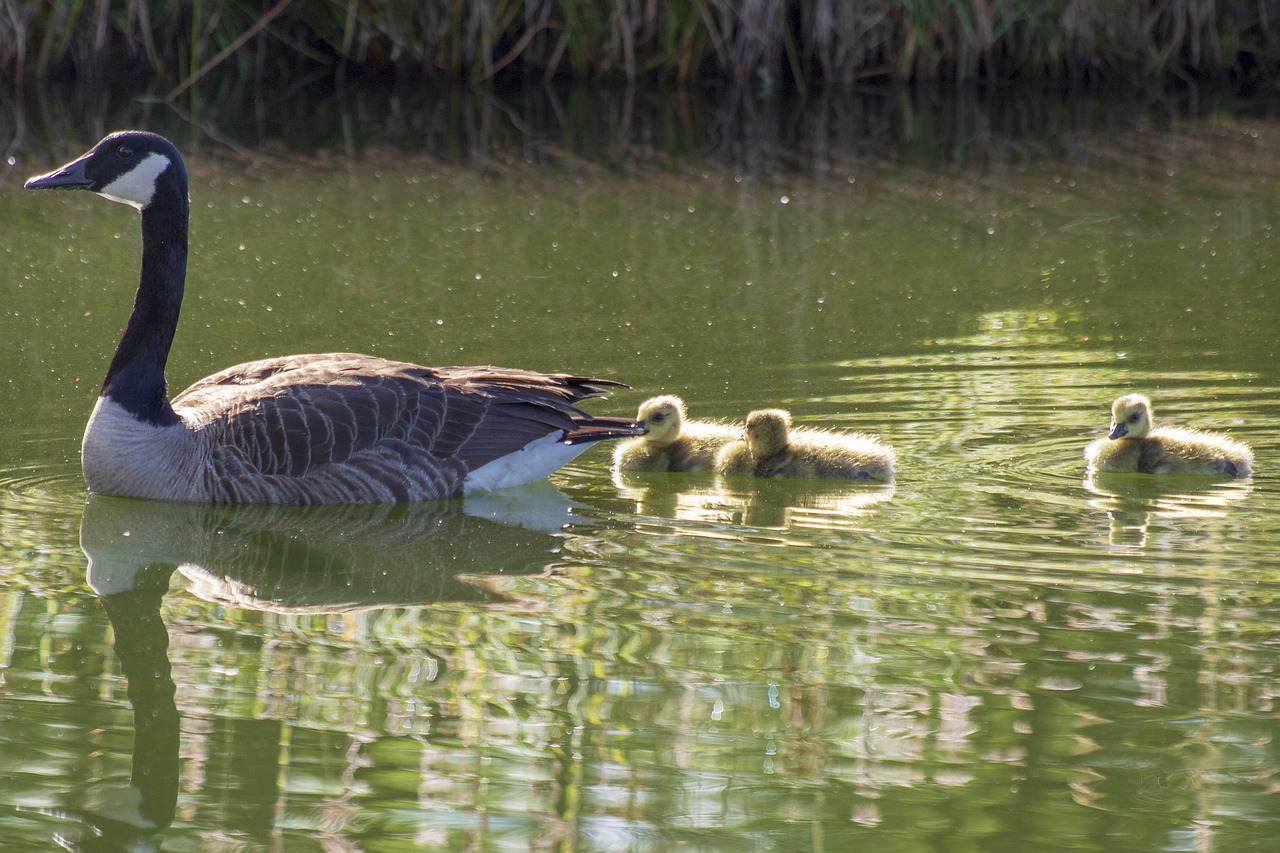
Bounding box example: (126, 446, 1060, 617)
(1084, 394, 1253, 476)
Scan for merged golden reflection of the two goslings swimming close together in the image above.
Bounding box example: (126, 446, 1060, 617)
(613, 461, 895, 529)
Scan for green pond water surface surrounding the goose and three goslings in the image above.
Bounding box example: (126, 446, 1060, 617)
(0, 87, 1280, 852)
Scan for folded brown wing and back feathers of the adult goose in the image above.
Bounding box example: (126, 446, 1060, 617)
(173, 353, 629, 503)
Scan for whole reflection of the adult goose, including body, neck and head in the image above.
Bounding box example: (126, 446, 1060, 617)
(50, 483, 573, 853)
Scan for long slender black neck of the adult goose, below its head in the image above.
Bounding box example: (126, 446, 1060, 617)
(102, 185, 191, 425)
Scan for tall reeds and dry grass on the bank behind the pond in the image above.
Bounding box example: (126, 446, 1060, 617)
(0, 0, 1280, 95)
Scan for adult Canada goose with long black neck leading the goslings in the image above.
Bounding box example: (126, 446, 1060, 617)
(27, 131, 643, 503)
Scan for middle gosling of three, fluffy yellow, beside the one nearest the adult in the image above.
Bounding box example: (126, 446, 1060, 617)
(716, 409, 895, 482)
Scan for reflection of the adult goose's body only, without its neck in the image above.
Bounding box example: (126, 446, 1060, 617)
(81, 483, 572, 604)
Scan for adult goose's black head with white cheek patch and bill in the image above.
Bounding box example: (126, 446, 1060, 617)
(26, 131, 187, 210)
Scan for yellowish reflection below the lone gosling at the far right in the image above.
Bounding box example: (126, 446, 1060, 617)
(1084, 471, 1253, 548)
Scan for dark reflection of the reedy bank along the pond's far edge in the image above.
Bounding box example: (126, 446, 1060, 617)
(0, 78, 1267, 179)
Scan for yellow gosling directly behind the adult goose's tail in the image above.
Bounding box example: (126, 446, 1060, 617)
(613, 394, 742, 471)
